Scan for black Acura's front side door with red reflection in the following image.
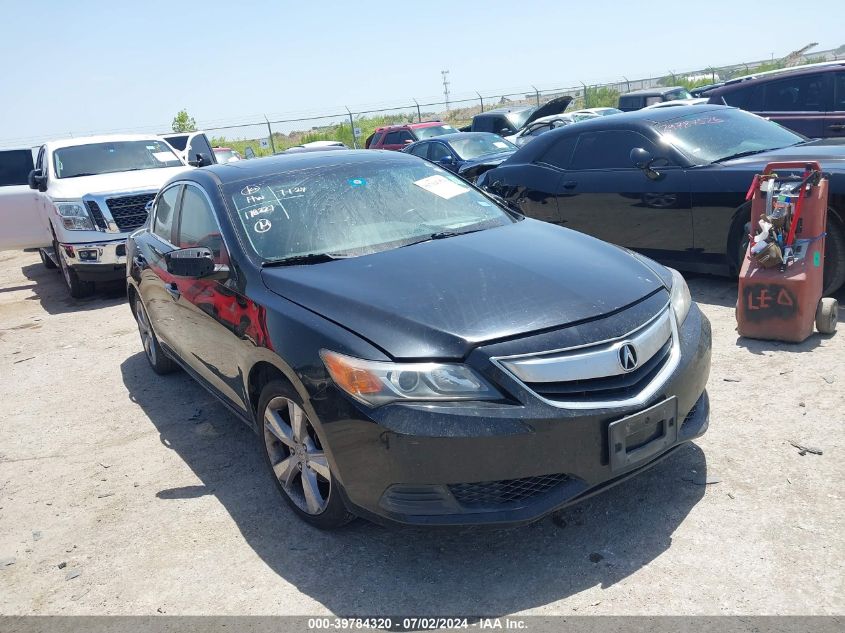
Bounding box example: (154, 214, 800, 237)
(168, 183, 249, 412)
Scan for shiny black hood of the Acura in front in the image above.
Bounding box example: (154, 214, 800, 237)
(262, 219, 662, 359)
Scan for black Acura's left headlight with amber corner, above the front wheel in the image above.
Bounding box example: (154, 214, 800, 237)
(320, 350, 501, 406)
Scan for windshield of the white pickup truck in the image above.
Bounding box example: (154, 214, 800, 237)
(53, 140, 182, 178)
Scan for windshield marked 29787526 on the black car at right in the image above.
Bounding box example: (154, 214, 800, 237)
(656, 108, 806, 165)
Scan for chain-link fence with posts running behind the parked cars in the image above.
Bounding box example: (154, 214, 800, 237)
(0, 47, 845, 156)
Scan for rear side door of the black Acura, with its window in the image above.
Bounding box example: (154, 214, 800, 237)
(137, 184, 182, 350)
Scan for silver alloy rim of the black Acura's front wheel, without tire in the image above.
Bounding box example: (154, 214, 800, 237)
(264, 397, 332, 515)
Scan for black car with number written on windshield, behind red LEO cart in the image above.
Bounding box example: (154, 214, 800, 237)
(478, 105, 845, 293)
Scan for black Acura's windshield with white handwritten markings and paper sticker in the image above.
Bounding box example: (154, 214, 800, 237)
(224, 152, 516, 263)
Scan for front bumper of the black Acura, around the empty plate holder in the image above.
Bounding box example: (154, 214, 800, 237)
(312, 306, 711, 526)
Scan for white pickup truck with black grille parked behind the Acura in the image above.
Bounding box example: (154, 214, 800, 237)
(0, 134, 214, 297)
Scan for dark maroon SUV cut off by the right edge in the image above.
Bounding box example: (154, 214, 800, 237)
(704, 61, 845, 138)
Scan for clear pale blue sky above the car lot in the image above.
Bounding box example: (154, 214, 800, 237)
(0, 0, 845, 146)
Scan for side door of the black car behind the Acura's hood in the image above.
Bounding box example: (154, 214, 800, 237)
(556, 130, 693, 255)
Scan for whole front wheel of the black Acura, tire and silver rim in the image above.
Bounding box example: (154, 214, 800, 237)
(258, 381, 354, 530)
